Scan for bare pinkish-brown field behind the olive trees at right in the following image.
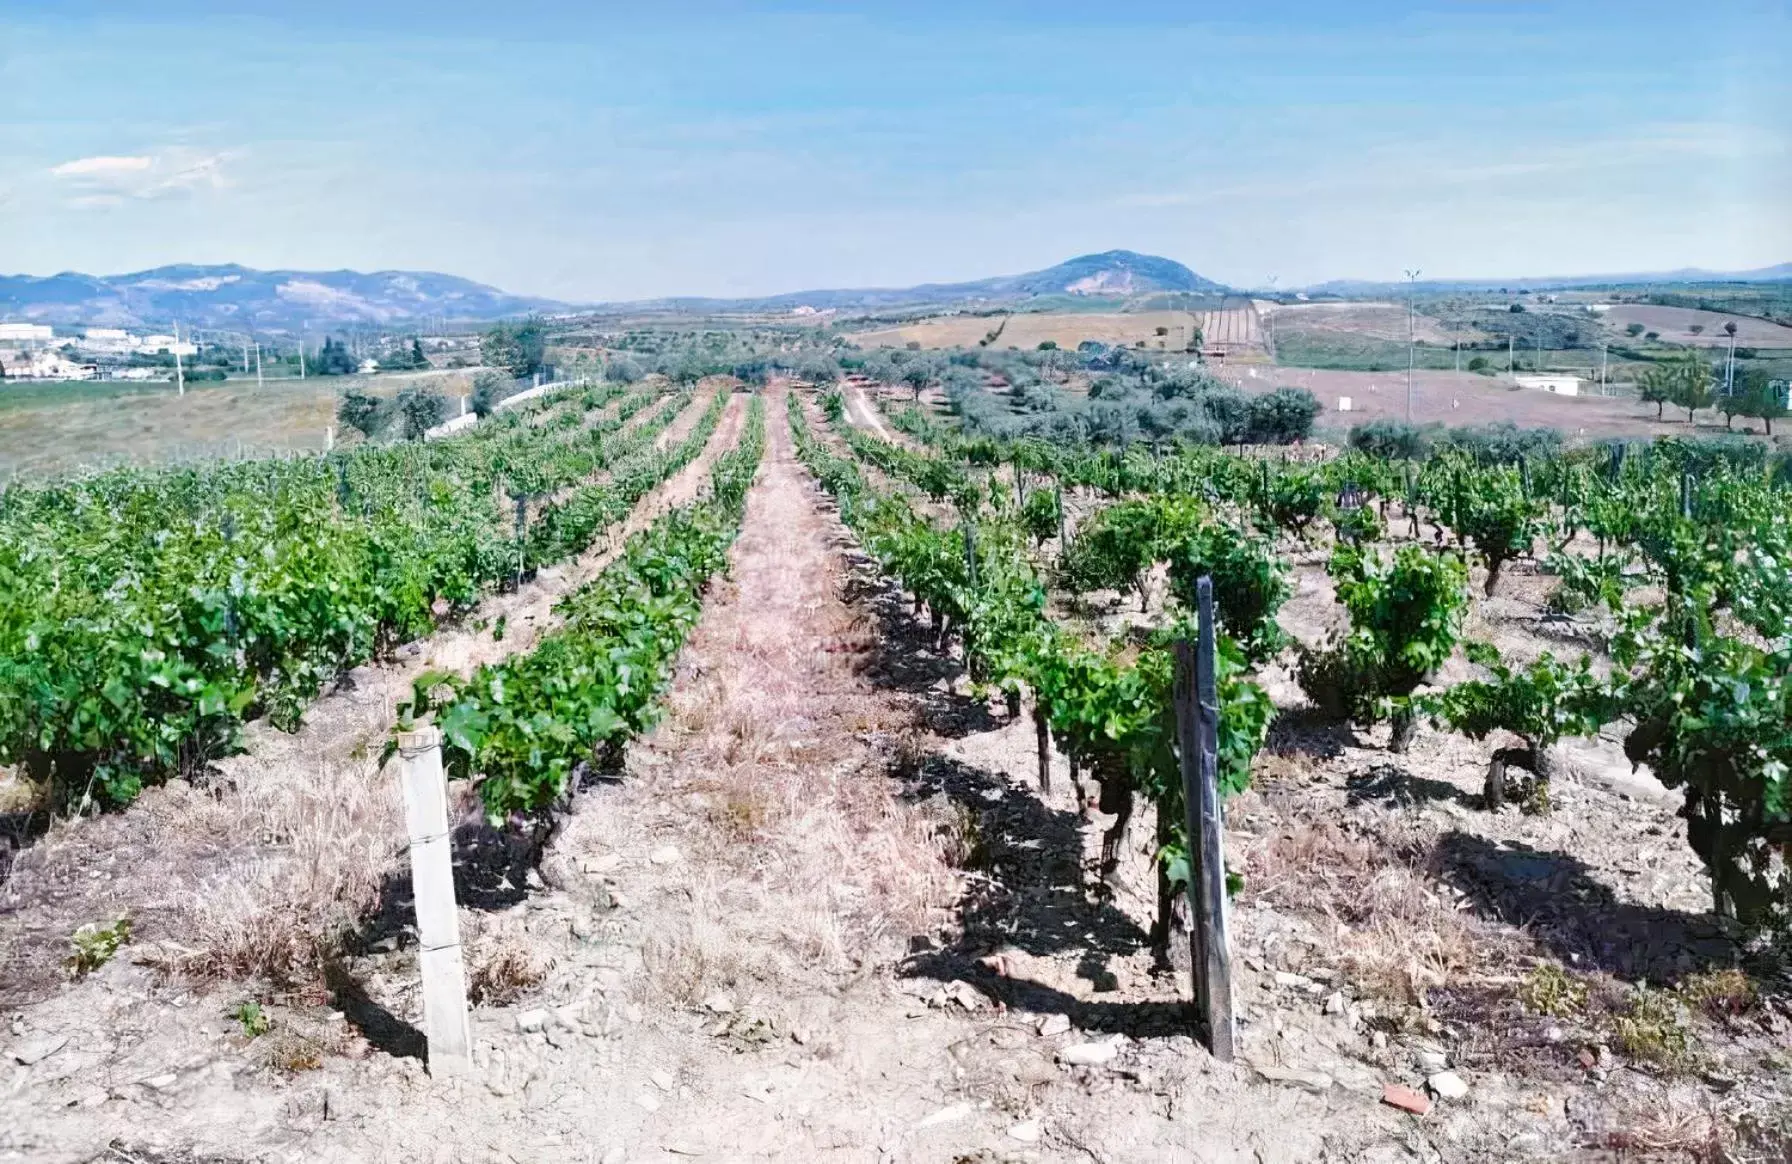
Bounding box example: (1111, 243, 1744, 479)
(1213, 367, 1749, 441)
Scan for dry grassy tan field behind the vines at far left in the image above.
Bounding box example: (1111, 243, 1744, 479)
(0, 372, 471, 476)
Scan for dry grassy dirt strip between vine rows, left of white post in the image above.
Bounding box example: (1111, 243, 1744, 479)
(0, 387, 745, 1006)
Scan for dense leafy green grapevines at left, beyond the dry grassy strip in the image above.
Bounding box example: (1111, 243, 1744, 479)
(0, 381, 713, 804)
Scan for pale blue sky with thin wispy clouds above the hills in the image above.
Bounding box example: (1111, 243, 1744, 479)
(0, 0, 1792, 303)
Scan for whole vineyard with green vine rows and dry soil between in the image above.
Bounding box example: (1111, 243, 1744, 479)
(0, 378, 1792, 1160)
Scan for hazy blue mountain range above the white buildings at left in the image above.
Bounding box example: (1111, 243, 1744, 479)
(0, 263, 568, 331)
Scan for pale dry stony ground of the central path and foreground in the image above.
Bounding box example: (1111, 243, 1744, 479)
(0, 392, 1792, 1164)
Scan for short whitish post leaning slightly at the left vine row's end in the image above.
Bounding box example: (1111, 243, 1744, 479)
(398, 727, 473, 1076)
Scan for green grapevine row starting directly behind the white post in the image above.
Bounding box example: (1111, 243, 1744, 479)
(401, 398, 765, 820)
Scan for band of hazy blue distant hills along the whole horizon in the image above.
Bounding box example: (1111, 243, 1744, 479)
(0, 251, 1792, 331)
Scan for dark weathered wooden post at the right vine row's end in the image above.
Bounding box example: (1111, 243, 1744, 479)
(1174, 577, 1236, 1062)
